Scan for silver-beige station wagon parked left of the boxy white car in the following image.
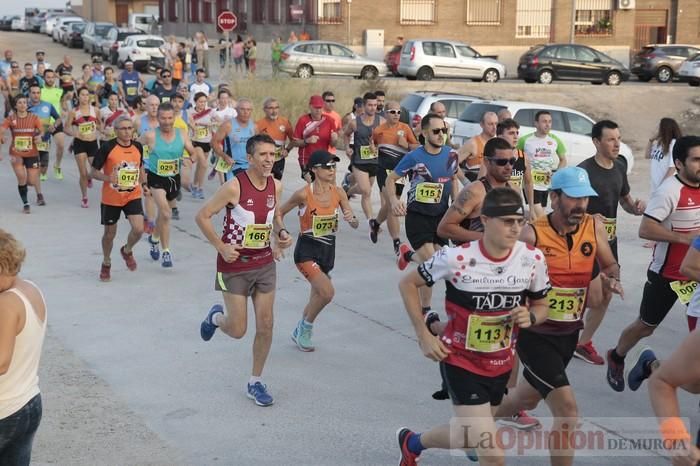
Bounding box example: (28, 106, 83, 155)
(280, 40, 389, 79)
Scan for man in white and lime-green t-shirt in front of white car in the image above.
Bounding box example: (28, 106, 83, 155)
(517, 110, 566, 217)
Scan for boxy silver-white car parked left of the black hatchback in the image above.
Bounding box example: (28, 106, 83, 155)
(399, 39, 506, 83)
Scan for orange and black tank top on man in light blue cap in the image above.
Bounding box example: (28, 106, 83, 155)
(532, 214, 597, 335)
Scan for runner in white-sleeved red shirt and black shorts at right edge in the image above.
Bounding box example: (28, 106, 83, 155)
(606, 136, 700, 392)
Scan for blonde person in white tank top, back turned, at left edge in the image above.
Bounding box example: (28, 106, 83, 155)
(0, 230, 46, 466)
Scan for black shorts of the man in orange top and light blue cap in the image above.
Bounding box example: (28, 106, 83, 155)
(516, 330, 579, 399)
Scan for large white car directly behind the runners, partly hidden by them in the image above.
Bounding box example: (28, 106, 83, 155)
(452, 100, 634, 174)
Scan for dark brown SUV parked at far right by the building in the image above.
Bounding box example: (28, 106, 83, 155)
(631, 44, 700, 83)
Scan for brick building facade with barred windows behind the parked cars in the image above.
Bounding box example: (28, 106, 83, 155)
(160, 0, 700, 50)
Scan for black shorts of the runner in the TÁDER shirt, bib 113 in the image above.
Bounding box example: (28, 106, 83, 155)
(440, 362, 510, 406)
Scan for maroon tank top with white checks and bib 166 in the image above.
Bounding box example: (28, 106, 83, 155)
(216, 171, 277, 272)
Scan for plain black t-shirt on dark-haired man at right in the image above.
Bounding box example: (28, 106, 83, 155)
(578, 157, 630, 218)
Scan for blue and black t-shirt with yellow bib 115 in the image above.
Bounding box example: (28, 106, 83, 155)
(394, 146, 457, 217)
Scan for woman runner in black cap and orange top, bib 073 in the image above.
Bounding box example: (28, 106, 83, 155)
(280, 150, 359, 351)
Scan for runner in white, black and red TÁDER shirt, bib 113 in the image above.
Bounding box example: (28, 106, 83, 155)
(397, 187, 550, 466)
